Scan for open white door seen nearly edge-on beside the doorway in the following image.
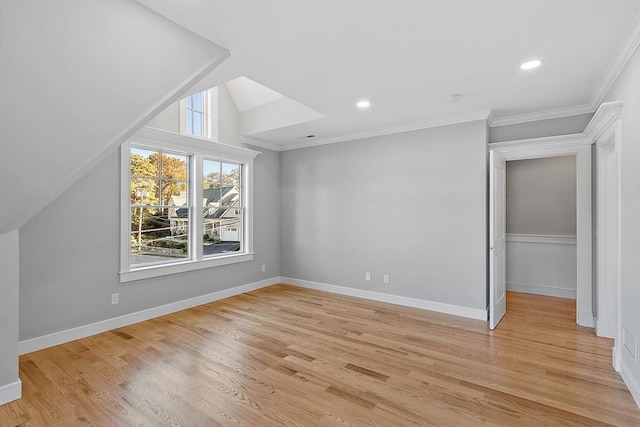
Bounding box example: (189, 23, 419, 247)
(489, 151, 507, 329)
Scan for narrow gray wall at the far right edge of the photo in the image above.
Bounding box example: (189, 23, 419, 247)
(605, 45, 640, 392)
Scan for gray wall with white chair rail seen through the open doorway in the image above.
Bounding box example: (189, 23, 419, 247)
(506, 156, 577, 300)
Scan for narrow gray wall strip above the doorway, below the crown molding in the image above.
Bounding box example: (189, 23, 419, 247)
(489, 113, 593, 142)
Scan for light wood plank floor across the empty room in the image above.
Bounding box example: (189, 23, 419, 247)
(0, 285, 640, 427)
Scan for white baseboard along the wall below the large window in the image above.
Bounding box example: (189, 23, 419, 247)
(18, 277, 280, 354)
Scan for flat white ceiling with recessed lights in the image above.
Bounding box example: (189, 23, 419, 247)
(140, 0, 640, 149)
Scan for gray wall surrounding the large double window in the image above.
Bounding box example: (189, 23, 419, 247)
(20, 146, 280, 340)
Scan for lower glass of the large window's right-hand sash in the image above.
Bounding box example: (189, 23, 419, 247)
(202, 214, 242, 256)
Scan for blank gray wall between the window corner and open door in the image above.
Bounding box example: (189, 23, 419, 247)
(280, 121, 487, 310)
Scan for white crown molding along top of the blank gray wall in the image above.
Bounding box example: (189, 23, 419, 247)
(281, 110, 491, 151)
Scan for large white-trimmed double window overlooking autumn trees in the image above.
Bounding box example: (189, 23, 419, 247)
(121, 128, 259, 282)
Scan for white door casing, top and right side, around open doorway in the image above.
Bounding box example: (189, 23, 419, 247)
(488, 133, 595, 328)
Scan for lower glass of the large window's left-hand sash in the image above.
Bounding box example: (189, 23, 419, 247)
(131, 208, 189, 266)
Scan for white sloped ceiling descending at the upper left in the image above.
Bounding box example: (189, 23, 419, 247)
(0, 0, 228, 234)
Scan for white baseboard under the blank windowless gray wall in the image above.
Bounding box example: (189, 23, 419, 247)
(280, 277, 487, 321)
